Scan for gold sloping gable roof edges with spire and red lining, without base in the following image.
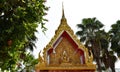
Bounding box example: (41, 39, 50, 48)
(43, 6, 88, 62)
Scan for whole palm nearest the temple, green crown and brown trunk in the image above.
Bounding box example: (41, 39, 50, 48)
(76, 18, 103, 72)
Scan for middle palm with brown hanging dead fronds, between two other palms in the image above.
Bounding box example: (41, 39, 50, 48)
(100, 31, 117, 72)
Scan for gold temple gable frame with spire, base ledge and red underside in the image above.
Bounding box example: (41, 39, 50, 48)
(35, 4, 96, 71)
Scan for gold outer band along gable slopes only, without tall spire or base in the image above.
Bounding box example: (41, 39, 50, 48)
(43, 18, 92, 64)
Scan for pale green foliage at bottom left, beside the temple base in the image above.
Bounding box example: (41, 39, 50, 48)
(14, 53, 38, 72)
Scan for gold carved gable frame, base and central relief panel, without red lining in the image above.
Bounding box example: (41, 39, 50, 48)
(36, 5, 96, 70)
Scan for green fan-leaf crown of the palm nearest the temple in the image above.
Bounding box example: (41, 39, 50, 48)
(76, 18, 104, 42)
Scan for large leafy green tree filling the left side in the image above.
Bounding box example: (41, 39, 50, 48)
(0, 0, 48, 71)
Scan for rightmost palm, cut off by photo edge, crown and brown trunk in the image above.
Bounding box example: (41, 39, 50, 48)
(104, 20, 120, 72)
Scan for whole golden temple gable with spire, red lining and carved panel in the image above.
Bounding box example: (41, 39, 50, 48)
(35, 4, 96, 72)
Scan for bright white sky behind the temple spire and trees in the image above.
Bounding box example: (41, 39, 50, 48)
(33, 0, 120, 68)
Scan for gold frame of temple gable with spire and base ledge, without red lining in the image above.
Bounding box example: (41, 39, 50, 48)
(35, 5, 96, 70)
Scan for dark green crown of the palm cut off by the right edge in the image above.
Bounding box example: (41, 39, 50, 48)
(109, 20, 120, 57)
